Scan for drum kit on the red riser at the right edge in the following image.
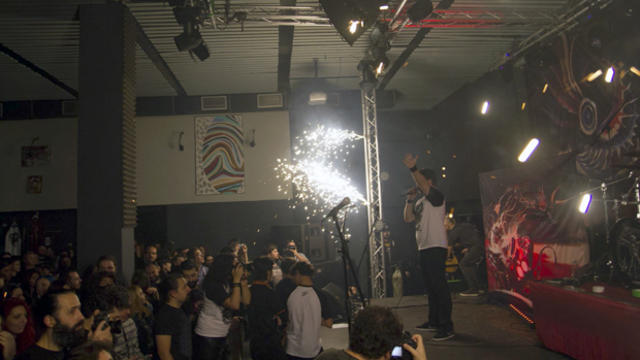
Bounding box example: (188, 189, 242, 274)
(595, 153, 640, 286)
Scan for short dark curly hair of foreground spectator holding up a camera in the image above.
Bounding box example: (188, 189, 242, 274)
(349, 306, 402, 359)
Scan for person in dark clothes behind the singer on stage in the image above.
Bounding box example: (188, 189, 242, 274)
(445, 218, 484, 296)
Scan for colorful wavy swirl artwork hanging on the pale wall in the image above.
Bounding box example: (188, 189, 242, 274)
(195, 115, 244, 195)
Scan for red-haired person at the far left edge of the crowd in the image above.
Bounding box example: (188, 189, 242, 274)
(0, 298, 36, 360)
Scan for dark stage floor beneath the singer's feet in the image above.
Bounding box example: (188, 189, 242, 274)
(321, 295, 570, 360)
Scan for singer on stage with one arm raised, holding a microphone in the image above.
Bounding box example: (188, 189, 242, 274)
(403, 154, 454, 341)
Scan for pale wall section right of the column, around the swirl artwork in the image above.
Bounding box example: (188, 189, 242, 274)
(136, 111, 290, 206)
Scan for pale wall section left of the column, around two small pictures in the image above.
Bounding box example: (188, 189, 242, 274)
(0, 119, 78, 212)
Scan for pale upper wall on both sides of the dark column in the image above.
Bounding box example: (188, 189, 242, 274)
(0, 111, 290, 212)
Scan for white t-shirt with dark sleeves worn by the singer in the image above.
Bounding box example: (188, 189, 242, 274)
(413, 187, 447, 250)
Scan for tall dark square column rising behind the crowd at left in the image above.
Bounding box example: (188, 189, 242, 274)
(78, 3, 136, 282)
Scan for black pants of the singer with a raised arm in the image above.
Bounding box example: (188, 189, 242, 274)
(420, 247, 453, 331)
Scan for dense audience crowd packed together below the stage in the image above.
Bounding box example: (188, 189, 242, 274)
(0, 240, 426, 360)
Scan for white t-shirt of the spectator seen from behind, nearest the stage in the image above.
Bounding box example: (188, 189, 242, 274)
(286, 285, 328, 358)
